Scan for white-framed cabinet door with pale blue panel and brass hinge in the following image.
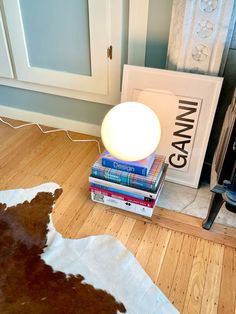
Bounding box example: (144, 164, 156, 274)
(3, 0, 109, 95)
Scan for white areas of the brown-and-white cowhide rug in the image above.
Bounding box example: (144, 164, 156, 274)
(0, 183, 178, 314)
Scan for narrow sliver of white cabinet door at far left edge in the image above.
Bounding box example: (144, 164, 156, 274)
(0, 11, 13, 78)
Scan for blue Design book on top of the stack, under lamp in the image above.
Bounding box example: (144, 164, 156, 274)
(101, 151, 156, 176)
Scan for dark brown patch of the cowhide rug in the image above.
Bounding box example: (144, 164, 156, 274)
(0, 189, 126, 314)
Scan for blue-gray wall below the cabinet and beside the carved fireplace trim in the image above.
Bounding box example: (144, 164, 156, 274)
(0, 0, 173, 125)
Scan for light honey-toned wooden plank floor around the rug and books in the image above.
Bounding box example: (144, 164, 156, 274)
(0, 122, 236, 314)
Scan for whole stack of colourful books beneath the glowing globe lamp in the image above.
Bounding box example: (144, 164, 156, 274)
(89, 151, 168, 217)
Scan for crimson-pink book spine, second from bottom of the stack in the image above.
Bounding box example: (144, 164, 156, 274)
(89, 186, 156, 208)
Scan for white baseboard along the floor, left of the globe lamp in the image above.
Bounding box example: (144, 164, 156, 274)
(0, 105, 101, 137)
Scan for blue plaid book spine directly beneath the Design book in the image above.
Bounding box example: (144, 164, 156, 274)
(91, 166, 158, 192)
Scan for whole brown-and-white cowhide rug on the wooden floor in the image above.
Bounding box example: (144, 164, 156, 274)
(0, 183, 177, 314)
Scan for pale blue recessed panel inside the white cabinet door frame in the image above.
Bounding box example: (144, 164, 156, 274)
(20, 0, 91, 76)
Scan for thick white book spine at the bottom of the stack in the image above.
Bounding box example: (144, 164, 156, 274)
(91, 192, 154, 217)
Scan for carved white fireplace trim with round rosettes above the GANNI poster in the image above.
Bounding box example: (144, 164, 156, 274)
(166, 0, 234, 75)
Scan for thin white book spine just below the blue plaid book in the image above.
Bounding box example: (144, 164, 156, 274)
(89, 176, 157, 199)
